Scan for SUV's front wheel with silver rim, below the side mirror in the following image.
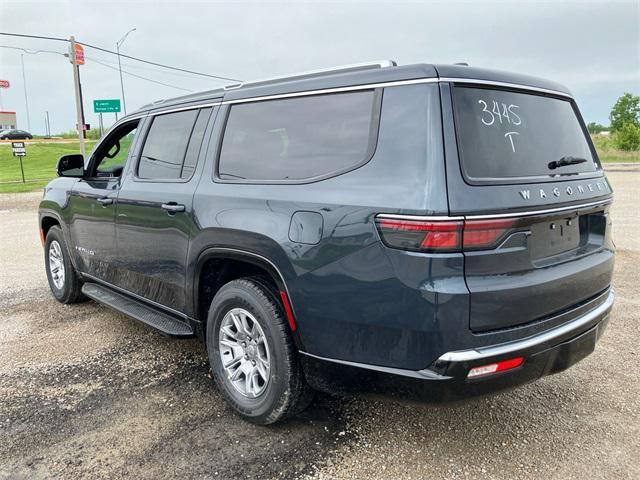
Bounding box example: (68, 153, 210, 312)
(44, 226, 83, 304)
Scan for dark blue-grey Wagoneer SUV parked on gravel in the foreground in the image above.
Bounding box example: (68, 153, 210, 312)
(39, 62, 614, 424)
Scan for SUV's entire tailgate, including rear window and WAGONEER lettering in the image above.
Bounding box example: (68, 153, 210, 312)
(443, 83, 613, 332)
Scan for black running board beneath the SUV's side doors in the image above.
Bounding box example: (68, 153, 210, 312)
(82, 283, 193, 337)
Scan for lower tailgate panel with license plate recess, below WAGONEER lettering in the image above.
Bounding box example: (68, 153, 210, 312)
(465, 201, 613, 332)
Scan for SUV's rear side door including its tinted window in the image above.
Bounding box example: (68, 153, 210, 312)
(116, 107, 213, 311)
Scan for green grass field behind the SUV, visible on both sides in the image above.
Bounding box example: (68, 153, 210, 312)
(0, 135, 640, 193)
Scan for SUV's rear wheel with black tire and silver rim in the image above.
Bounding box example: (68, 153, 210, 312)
(206, 278, 313, 425)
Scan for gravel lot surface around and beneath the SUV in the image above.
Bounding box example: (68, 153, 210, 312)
(0, 170, 640, 480)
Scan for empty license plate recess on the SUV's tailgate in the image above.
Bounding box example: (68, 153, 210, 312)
(531, 215, 581, 260)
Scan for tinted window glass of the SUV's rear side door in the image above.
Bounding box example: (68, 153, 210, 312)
(138, 108, 211, 180)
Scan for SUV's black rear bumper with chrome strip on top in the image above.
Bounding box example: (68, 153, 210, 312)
(300, 291, 614, 402)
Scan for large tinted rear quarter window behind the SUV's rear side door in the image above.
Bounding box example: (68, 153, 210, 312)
(218, 90, 379, 181)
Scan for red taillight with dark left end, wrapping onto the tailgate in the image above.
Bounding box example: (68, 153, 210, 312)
(376, 215, 517, 252)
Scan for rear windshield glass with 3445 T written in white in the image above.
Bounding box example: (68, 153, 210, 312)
(453, 87, 596, 182)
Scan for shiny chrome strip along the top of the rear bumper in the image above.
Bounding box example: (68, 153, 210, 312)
(437, 291, 615, 362)
